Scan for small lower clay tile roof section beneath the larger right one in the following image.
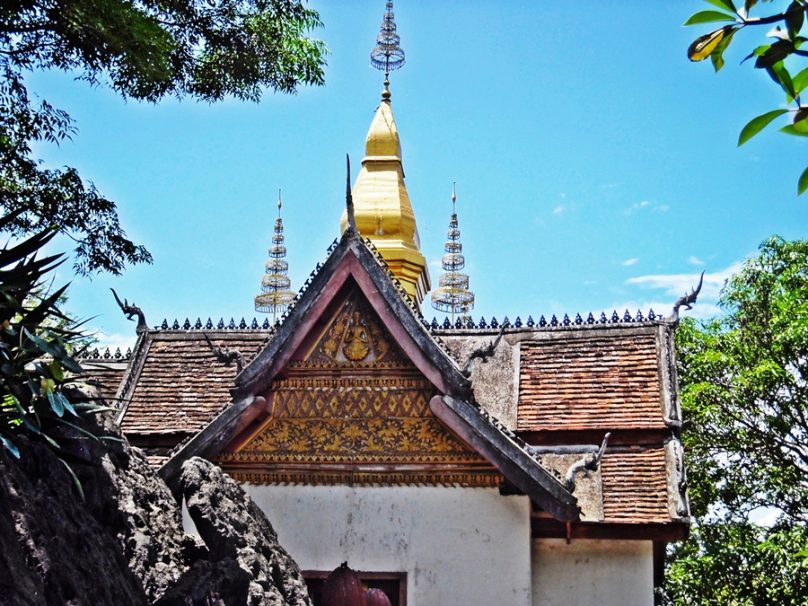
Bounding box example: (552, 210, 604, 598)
(601, 446, 671, 523)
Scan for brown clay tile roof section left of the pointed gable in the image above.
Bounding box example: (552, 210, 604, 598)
(121, 330, 268, 436)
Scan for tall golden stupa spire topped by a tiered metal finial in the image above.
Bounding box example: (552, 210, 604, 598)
(340, 1, 430, 305)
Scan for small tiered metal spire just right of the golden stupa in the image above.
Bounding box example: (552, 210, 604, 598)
(432, 183, 474, 325)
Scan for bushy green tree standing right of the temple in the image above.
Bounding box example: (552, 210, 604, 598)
(667, 237, 808, 604)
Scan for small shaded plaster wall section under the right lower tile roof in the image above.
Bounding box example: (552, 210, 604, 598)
(532, 539, 654, 606)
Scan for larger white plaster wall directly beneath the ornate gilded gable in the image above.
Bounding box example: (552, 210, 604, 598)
(244, 485, 531, 606)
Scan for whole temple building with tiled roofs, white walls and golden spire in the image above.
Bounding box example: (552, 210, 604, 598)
(85, 3, 689, 606)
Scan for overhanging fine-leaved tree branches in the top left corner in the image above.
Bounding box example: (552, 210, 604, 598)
(0, 0, 326, 273)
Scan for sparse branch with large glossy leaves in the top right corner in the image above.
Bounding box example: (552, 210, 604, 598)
(685, 0, 808, 195)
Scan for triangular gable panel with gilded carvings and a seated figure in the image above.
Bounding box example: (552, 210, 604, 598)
(218, 281, 502, 486)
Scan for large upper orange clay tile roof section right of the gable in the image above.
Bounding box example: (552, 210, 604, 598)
(517, 327, 665, 431)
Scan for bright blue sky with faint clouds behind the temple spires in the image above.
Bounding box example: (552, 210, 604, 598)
(26, 0, 808, 352)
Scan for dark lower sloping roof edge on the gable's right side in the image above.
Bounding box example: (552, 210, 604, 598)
(429, 396, 580, 522)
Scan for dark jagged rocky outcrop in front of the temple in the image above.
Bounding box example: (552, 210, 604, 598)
(0, 402, 311, 606)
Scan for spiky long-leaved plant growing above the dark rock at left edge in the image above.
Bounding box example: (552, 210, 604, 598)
(0, 216, 99, 464)
